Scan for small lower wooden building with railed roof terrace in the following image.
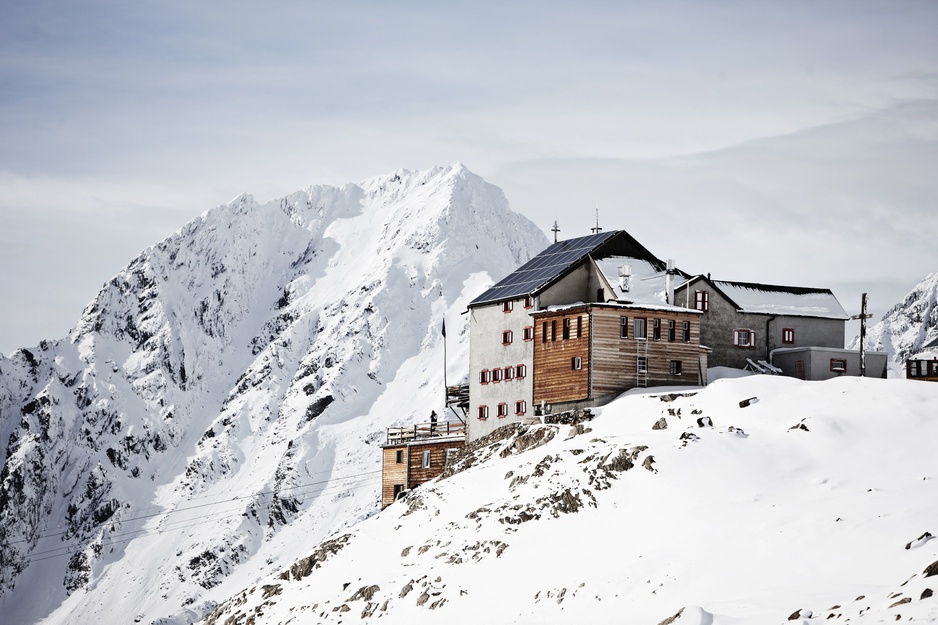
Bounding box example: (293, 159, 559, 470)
(381, 423, 466, 509)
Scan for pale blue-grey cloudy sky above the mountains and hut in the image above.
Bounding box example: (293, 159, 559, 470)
(0, 0, 938, 354)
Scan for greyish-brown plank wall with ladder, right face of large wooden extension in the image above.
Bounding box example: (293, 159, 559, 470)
(590, 307, 700, 398)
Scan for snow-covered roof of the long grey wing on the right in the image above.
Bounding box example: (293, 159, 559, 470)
(712, 280, 850, 320)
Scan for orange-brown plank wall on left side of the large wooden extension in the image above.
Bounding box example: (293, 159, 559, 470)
(533, 306, 590, 406)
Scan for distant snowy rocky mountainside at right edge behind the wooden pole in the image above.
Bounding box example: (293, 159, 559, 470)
(850, 272, 938, 378)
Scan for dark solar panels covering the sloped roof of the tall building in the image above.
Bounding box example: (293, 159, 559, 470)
(469, 231, 616, 306)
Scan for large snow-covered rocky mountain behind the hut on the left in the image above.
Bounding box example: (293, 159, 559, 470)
(0, 165, 548, 623)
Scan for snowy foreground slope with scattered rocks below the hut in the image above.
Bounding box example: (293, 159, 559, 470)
(202, 376, 938, 625)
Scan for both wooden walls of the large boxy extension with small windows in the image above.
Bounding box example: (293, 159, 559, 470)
(533, 304, 707, 407)
